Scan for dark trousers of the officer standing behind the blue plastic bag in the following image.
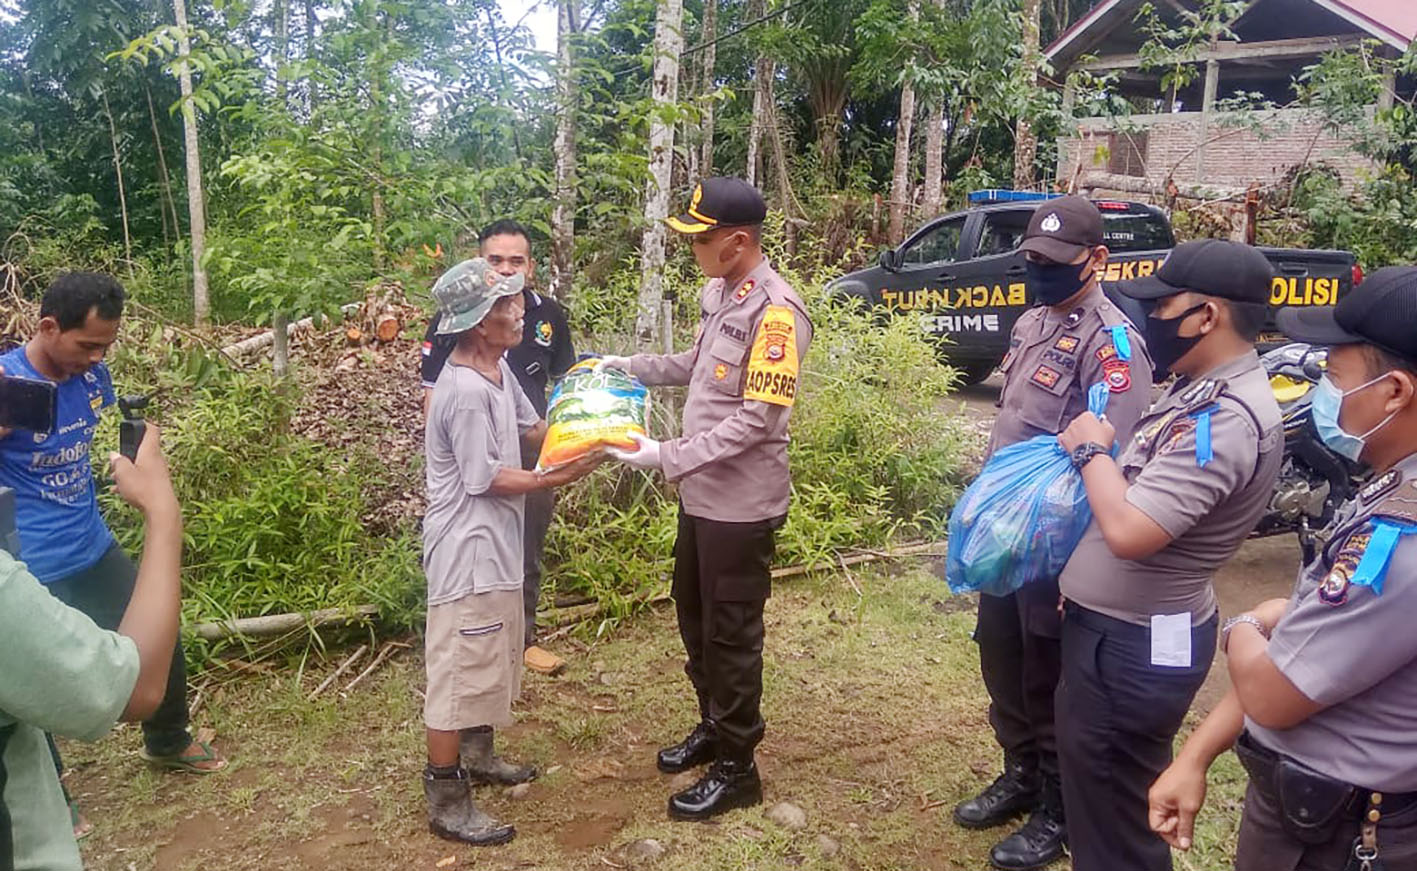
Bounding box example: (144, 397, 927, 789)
(975, 578, 1063, 778)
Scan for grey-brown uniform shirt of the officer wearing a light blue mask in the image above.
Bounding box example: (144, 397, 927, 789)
(1246, 455, 1417, 793)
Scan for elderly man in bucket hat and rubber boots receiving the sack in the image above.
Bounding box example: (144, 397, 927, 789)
(424, 258, 602, 846)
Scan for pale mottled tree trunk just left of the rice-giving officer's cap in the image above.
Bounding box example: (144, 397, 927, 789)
(635, 0, 684, 353)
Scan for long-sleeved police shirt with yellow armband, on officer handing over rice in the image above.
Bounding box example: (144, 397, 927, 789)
(629, 261, 812, 523)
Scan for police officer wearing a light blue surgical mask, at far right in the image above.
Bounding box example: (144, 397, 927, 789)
(1151, 266, 1417, 871)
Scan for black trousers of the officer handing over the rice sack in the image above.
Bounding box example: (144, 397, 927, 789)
(673, 508, 784, 759)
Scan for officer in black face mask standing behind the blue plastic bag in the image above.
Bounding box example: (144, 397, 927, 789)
(954, 197, 1152, 870)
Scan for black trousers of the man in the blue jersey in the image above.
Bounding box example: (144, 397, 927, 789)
(47, 544, 191, 756)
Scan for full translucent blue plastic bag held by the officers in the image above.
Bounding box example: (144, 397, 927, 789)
(945, 384, 1117, 596)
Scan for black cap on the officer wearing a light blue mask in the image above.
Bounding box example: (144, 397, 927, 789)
(1278, 266, 1417, 363)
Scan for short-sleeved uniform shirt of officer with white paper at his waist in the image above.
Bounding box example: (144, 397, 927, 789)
(1058, 351, 1284, 625)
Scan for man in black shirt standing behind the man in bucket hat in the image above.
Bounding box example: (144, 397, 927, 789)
(421, 221, 575, 674)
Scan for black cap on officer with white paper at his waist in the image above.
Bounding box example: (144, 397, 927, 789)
(1117, 239, 1274, 304)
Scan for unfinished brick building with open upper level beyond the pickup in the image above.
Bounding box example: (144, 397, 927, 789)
(1044, 0, 1417, 193)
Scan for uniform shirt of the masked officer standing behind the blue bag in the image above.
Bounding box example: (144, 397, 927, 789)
(985, 288, 1152, 457)
